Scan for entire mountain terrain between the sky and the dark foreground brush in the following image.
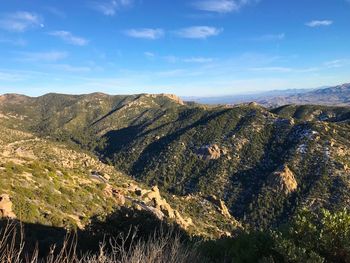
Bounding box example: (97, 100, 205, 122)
(0, 85, 350, 237)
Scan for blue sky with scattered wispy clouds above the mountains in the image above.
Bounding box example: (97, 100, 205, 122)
(0, 0, 350, 96)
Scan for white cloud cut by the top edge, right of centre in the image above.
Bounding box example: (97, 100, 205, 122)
(192, 0, 259, 13)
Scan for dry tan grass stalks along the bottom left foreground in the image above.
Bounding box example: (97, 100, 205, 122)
(0, 223, 203, 263)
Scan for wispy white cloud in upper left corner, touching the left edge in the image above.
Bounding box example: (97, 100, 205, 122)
(0, 11, 44, 32)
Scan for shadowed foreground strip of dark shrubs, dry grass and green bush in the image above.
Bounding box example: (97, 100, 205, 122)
(0, 210, 350, 263)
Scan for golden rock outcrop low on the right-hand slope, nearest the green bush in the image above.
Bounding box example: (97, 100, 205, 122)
(268, 165, 298, 194)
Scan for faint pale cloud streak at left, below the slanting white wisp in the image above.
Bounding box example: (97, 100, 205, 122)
(17, 51, 68, 62)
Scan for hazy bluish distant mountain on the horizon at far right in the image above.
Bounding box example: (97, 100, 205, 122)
(257, 84, 350, 107)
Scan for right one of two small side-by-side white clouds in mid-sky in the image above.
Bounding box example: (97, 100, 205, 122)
(175, 26, 223, 39)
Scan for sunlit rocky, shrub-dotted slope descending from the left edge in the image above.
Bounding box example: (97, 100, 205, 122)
(0, 118, 240, 237)
